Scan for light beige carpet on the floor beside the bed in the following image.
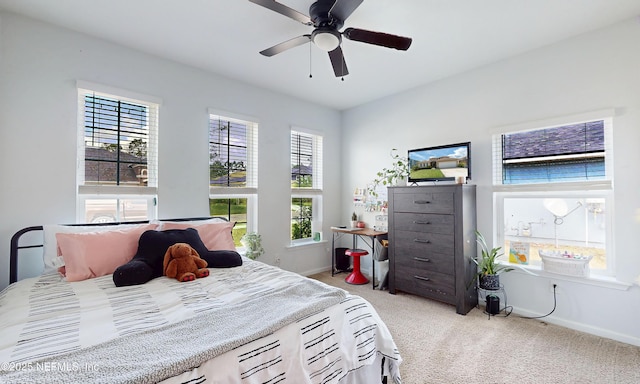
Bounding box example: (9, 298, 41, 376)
(310, 272, 640, 384)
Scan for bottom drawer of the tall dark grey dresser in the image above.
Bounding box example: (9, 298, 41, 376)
(395, 266, 456, 302)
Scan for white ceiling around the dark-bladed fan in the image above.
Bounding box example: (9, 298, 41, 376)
(0, 0, 640, 110)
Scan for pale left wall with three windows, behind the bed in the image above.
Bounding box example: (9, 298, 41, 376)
(0, 13, 341, 289)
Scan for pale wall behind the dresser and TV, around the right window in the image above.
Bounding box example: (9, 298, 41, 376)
(342, 19, 640, 345)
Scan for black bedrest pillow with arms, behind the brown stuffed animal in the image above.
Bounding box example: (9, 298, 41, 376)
(113, 228, 242, 287)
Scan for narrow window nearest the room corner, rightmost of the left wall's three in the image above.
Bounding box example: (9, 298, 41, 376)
(291, 131, 322, 241)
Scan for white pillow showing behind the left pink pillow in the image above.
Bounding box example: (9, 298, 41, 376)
(42, 224, 148, 272)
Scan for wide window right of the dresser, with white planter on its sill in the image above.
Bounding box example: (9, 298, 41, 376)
(493, 111, 614, 275)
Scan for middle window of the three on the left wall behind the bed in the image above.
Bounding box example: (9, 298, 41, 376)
(209, 112, 258, 247)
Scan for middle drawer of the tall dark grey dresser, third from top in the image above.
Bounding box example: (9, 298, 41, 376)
(393, 230, 455, 256)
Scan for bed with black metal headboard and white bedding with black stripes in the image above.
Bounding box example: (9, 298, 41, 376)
(0, 218, 402, 384)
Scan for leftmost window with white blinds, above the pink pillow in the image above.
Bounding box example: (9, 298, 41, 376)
(77, 82, 159, 223)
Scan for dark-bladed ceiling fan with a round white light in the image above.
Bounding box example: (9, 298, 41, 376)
(249, 0, 412, 77)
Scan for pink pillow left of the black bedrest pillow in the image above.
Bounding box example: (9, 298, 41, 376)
(56, 224, 158, 281)
